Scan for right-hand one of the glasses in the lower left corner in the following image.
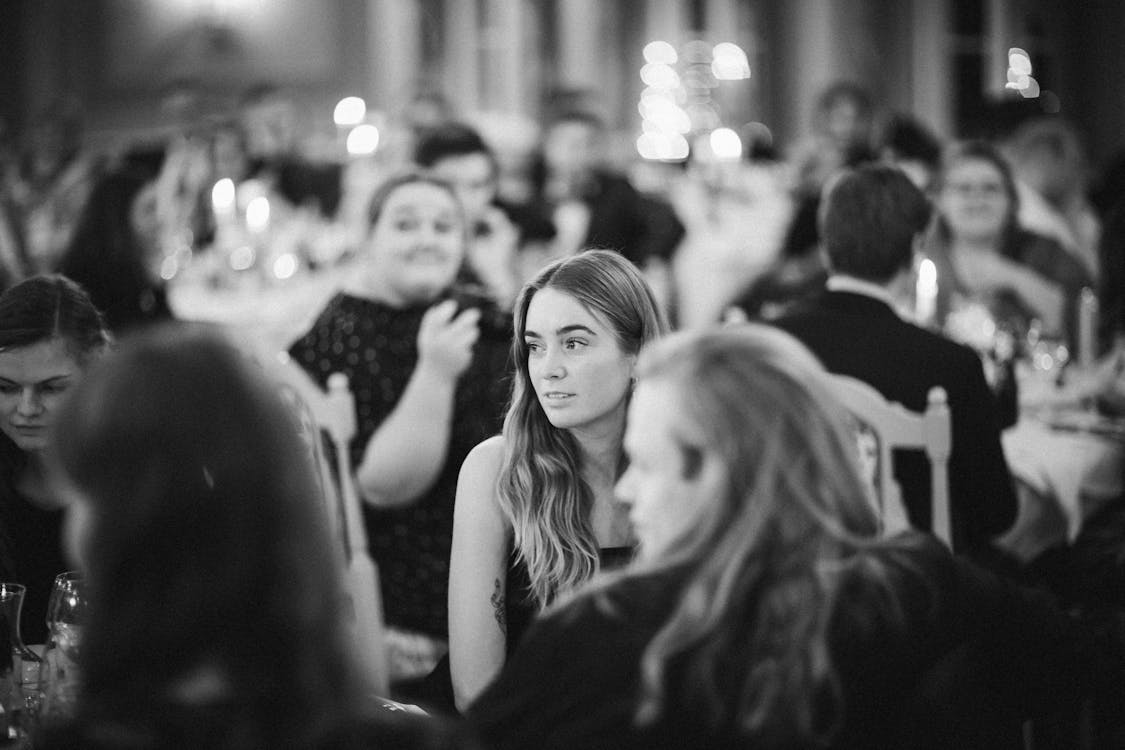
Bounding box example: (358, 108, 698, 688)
(39, 570, 87, 716)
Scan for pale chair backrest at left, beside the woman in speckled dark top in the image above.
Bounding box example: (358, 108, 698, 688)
(270, 352, 388, 695)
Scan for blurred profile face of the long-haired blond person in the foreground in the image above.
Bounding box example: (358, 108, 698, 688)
(617, 380, 720, 558)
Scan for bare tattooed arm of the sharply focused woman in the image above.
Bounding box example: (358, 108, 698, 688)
(449, 437, 511, 711)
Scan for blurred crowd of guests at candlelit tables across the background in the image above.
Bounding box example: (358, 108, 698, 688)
(0, 81, 1125, 364)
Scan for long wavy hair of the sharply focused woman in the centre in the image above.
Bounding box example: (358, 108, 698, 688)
(497, 250, 668, 607)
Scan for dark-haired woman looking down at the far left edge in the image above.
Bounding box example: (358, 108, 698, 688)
(0, 275, 109, 643)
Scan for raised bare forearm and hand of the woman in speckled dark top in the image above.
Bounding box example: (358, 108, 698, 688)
(356, 300, 480, 506)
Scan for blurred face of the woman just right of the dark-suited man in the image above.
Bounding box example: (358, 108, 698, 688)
(938, 159, 1011, 241)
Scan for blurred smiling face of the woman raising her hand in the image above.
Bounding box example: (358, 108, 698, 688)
(368, 182, 465, 306)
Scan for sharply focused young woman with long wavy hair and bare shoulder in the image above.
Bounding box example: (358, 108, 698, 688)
(449, 250, 667, 707)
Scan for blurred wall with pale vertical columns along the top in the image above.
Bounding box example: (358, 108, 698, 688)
(0, 0, 1125, 172)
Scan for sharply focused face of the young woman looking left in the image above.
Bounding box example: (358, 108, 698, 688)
(523, 289, 637, 428)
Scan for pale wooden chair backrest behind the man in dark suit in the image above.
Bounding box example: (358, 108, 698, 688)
(828, 374, 953, 549)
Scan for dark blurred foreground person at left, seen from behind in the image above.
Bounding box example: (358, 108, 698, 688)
(36, 327, 472, 750)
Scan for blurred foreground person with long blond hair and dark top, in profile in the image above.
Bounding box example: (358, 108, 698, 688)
(468, 325, 1125, 750)
